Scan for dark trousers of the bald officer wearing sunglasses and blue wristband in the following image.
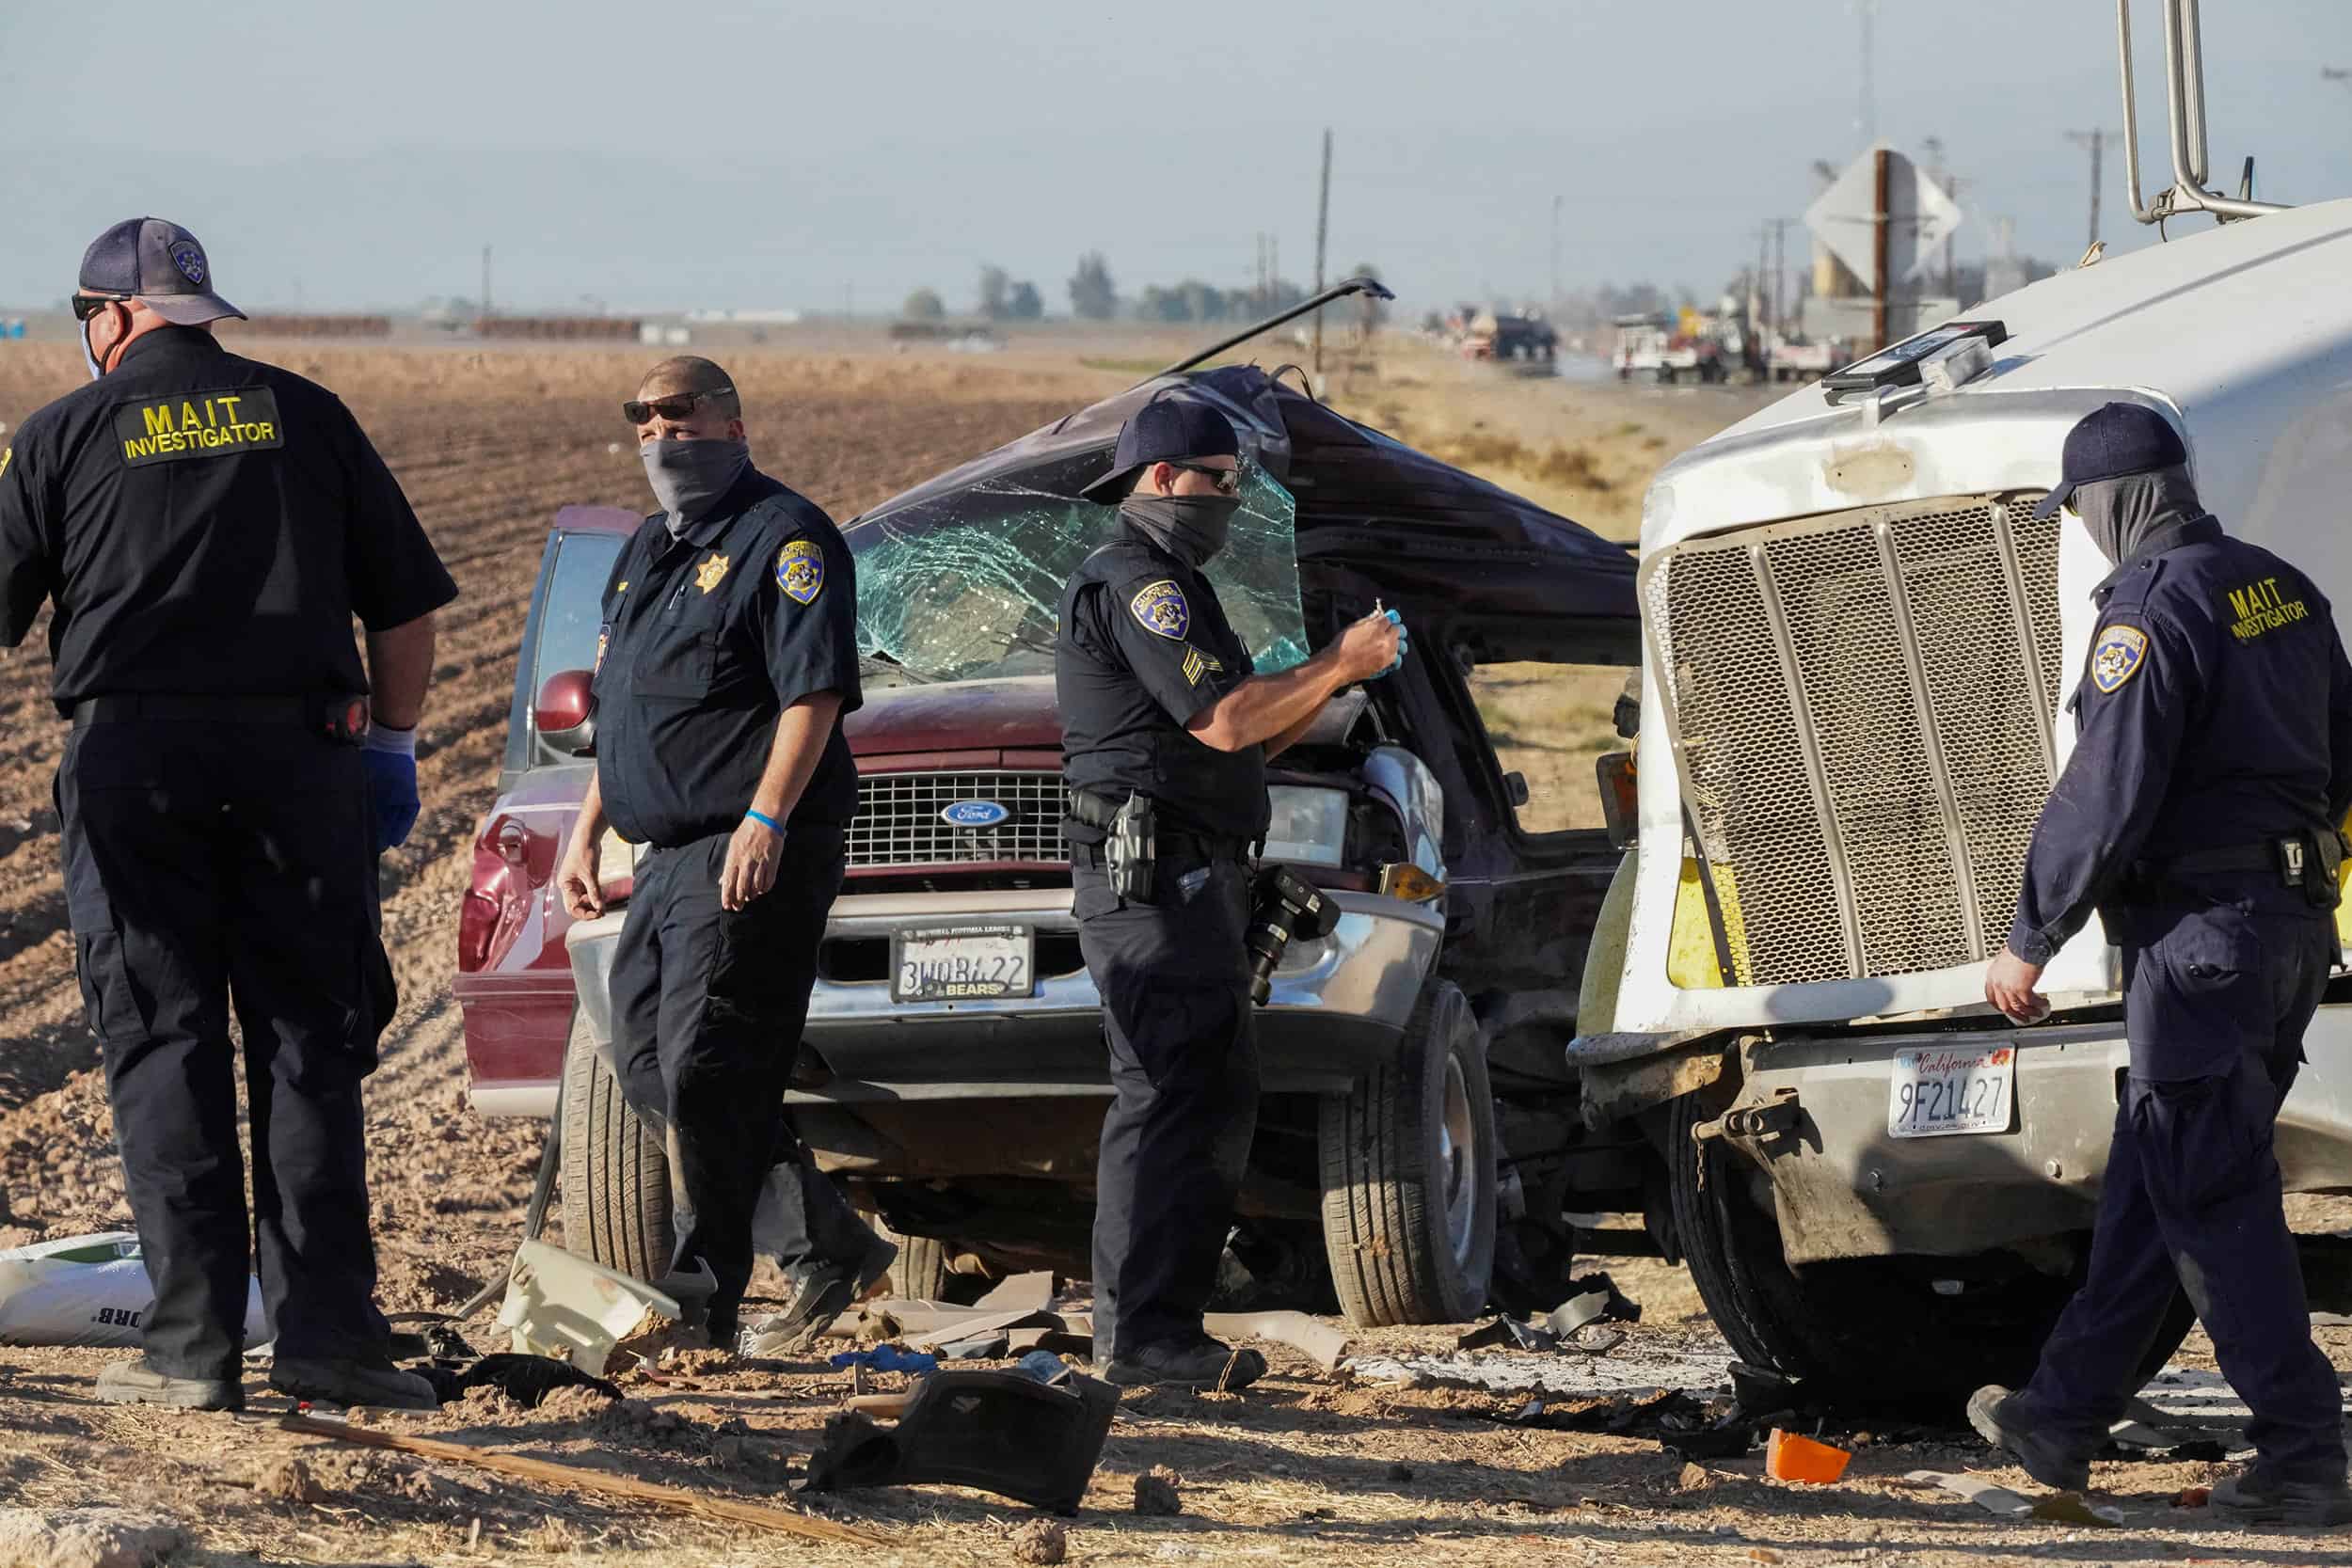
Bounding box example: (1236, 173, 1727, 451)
(612, 828, 873, 1331)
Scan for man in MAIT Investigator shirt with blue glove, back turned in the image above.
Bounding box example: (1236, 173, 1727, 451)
(0, 218, 456, 1411)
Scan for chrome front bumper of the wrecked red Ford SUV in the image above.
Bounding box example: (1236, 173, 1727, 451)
(524, 889, 1444, 1115)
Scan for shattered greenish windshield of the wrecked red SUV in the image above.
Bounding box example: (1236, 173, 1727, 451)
(850, 444, 1308, 687)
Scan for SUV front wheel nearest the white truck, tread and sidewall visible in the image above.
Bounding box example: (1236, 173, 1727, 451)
(1320, 980, 1499, 1328)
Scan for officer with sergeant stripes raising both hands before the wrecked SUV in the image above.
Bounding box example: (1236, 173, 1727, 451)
(1054, 395, 1405, 1387)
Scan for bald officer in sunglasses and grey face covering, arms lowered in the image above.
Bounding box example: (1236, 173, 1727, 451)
(560, 357, 898, 1350)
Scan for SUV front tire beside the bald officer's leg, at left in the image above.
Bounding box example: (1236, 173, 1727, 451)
(558, 1008, 677, 1281)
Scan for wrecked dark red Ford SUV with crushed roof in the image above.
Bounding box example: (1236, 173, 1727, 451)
(456, 355, 1642, 1323)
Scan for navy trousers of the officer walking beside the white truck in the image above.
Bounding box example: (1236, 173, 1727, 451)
(2021, 908, 2345, 1479)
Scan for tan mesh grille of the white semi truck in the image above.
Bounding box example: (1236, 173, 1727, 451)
(1642, 496, 2060, 985)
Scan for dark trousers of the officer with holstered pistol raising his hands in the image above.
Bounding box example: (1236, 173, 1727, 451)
(1071, 837, 1259, 1361)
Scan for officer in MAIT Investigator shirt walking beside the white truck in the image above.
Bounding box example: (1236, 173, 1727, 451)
(1969, 402, 2352, 1524)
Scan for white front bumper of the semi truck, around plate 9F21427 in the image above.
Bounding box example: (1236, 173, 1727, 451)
(1726, 1006, 2352, 1265)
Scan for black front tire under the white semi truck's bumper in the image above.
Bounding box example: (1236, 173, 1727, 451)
(1668, 1096, 2197, 1411)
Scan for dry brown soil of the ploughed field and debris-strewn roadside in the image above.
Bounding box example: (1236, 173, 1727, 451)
(0, 333, 2352, 1566)
